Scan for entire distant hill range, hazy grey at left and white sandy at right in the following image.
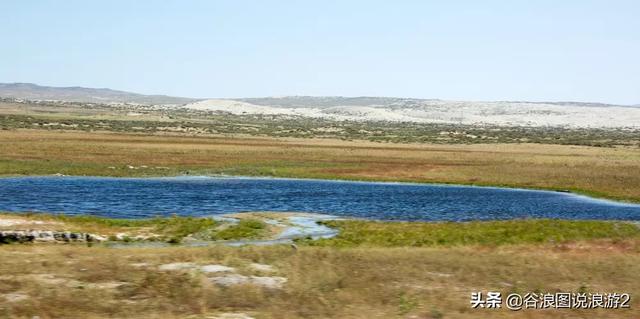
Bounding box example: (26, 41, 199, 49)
(0, 83, 640, 128)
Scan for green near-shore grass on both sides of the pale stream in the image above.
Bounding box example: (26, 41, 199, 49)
(6, 214, 640, 247)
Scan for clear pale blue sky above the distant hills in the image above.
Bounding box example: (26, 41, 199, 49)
(0, 0, 640, 104)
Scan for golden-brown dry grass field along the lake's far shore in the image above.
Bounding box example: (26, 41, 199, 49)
(0, 130, 640, 201)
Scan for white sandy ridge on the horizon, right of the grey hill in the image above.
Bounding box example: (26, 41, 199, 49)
(184, 99, 640, 128)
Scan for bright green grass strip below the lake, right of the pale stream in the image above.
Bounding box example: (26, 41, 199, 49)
(300, 219, 640, 247)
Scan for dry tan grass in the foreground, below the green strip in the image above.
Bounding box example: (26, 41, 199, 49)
(0, 242, 640, 319)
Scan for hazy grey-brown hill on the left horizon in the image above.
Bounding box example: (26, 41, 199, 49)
(0, 83, 198, 104)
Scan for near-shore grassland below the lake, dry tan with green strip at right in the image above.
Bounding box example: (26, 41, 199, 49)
(0, 215, 640, 318)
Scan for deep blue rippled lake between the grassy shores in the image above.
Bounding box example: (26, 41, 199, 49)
(0, 177, 640, 221)
